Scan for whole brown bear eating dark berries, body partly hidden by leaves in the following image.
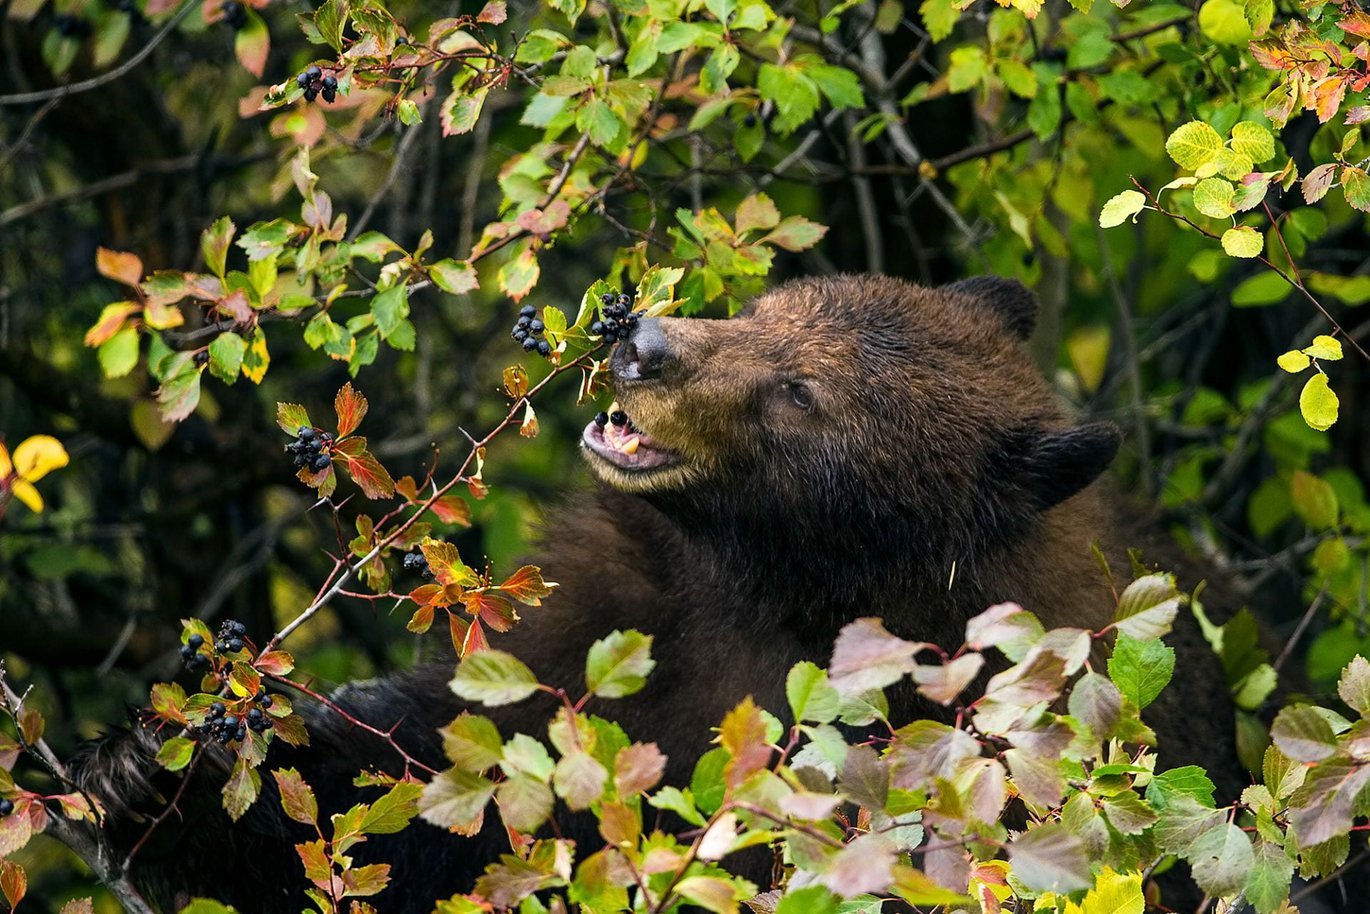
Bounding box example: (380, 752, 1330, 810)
(78, 275, 1241, 914)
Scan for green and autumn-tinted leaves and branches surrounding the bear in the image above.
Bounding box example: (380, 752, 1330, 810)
(0, 0, 1370, 914)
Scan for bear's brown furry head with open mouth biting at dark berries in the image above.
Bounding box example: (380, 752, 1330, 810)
(582, 275, 1119, 624)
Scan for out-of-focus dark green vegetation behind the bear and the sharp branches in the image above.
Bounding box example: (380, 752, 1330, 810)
(0, 0, 1370, 910)
